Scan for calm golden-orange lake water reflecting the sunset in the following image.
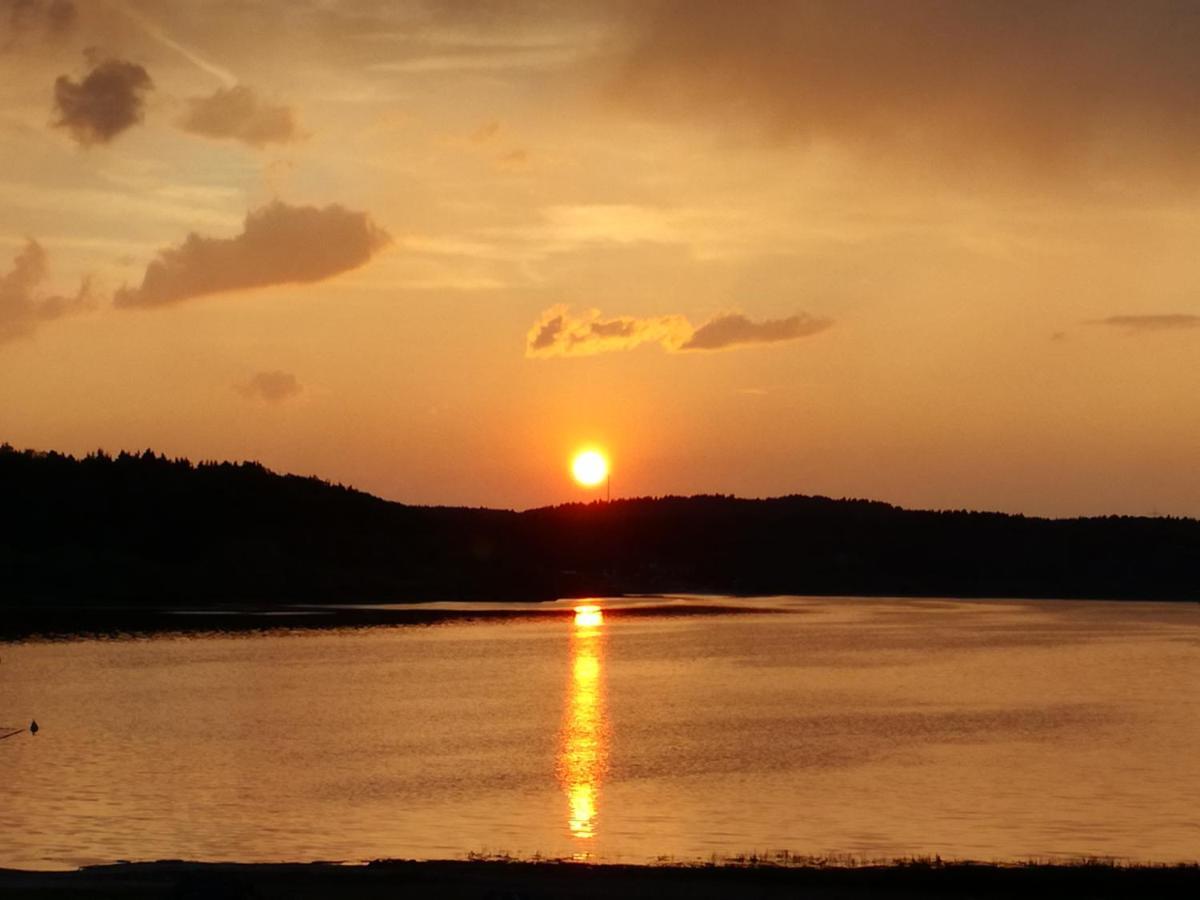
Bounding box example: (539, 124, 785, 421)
(0, 599, 1200, 868)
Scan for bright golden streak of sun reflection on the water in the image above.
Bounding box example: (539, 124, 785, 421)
(557, 606, 608, 859)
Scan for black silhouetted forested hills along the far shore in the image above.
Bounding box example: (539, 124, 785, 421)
(0, 445, 1200, 608)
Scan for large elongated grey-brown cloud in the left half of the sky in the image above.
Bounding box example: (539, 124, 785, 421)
(113, 200, 391, 307)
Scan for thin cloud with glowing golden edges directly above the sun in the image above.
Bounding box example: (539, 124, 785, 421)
(526, 305, 833, 359)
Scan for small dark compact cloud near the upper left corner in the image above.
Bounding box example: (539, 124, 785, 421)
(54, 59, 154, 146)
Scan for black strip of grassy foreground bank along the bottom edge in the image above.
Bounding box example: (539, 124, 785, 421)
(0, 862, 1200, 900)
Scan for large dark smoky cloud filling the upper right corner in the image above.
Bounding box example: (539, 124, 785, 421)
(612, 0, 1200, 182)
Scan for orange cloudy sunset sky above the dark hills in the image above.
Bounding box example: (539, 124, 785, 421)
(0, 0, 1200, 516)
